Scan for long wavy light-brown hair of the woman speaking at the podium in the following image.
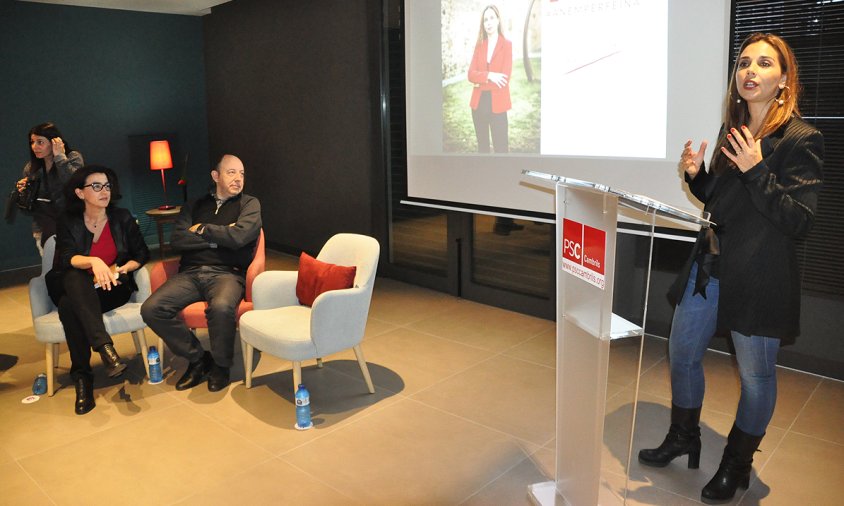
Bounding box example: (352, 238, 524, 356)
(712, 32, 802, 174)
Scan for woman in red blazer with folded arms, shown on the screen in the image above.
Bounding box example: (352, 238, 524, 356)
(469, 5, 513, 153)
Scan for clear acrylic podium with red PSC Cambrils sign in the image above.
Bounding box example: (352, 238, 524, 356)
(522, 170, 712, 506)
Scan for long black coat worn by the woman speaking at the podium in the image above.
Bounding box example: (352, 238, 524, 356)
(669, 117, 823, 344)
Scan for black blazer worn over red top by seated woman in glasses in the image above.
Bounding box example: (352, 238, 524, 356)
(47, 207, 149, 290)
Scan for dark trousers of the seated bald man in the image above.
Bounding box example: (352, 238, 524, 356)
(141, 266, 246, 367)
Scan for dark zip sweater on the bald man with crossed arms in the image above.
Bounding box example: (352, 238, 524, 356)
(170, 193, 261, 273)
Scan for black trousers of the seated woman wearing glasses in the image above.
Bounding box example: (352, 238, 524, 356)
(58, 269, 134, 380)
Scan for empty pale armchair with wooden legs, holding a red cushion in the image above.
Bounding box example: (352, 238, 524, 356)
(240, 234, 380, 393)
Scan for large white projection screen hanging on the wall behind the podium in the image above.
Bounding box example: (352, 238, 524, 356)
(405, 0, 729, 227)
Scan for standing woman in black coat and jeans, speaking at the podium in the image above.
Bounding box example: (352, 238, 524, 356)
(639, 33, 823, 504)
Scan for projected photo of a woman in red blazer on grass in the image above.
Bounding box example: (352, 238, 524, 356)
(441, 0, 541, 153)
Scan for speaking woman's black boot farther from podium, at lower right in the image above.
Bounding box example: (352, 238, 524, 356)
(700, 424, 765, 504)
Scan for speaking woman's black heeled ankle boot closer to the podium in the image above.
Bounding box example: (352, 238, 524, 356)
(639, 404, 700, 469)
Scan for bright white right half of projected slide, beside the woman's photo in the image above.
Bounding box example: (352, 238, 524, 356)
(541, 0, 668, 158)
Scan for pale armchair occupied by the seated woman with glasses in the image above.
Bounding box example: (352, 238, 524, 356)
(29, 236, 150, 396)
